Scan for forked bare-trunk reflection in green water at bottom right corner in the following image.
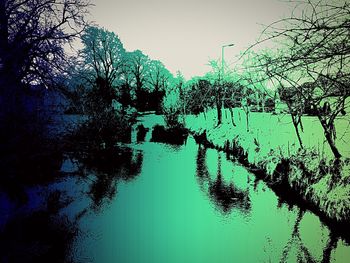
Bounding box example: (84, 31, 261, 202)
(280, 209, 338, 263)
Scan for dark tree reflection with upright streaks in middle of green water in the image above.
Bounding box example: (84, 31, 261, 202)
(196, 145, 250, 217)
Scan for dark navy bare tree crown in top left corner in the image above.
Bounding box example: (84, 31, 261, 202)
(0, 0, 89, 91)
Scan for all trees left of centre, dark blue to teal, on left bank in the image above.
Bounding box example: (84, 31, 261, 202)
(0, 0, 179, 153)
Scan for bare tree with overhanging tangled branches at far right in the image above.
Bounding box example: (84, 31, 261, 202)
(243, 0, 350, 158)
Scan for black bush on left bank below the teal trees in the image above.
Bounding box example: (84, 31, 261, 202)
(67, 77, 137, 151)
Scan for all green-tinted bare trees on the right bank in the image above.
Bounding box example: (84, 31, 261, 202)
(166, 0, 350, 159)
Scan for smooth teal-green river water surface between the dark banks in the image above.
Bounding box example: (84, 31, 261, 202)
(71, 116, 350, 263)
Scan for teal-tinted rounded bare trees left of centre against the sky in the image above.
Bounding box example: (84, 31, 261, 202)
(69, 26, 173, 113)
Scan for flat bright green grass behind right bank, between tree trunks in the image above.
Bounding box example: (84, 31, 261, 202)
(186, 108, 350, 159)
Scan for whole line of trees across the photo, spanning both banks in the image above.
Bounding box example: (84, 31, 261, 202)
(0, 0, 350, 161)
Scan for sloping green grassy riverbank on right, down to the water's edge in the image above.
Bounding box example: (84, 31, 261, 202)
(186, 109, 350, 227)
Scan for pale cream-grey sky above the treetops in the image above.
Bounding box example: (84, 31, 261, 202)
(91, 0, 290, 79)
